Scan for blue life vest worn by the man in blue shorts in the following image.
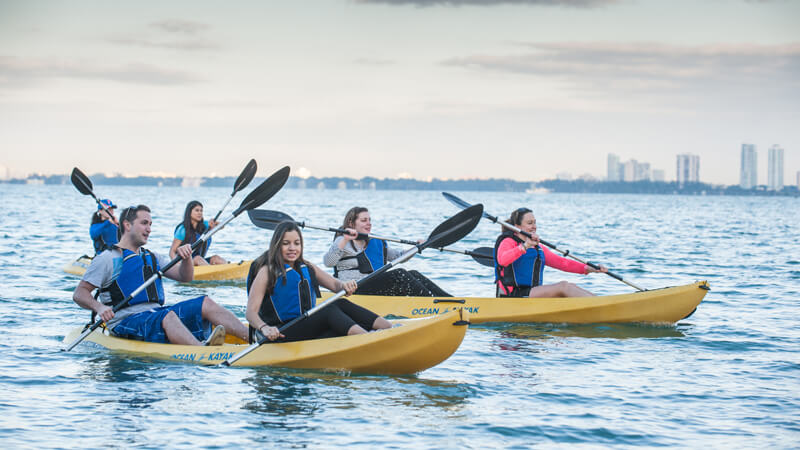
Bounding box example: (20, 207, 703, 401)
(101, 247, 164, 307)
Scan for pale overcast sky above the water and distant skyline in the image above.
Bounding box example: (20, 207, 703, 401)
(0, 0, 800, 184)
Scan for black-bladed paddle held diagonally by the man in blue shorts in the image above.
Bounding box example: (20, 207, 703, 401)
(63, 166, 289, 352)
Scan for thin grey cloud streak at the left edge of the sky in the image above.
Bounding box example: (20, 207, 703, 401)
(0, 56, 202, 87)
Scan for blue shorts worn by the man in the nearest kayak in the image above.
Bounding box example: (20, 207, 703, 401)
(112, 295, 211, 344)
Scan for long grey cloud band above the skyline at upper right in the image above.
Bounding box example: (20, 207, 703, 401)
(442, 42, 800, 108)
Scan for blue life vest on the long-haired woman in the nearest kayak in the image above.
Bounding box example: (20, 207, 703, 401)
(253, 264, 319, 326)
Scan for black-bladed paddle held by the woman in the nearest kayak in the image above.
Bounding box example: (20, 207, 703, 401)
(221, 204, 483, 366)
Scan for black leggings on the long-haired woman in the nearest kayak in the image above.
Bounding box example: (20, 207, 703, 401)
(256, 298, 378, 342)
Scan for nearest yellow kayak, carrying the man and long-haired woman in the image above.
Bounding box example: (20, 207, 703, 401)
(64, 309, 469, 375)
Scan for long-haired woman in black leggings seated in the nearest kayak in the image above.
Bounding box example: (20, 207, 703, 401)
(246, 221, 392, 343)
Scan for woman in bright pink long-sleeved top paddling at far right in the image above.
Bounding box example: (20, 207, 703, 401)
(494, 208, 608, 297)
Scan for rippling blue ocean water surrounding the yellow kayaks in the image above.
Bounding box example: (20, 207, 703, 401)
(0, 184, 800, 448)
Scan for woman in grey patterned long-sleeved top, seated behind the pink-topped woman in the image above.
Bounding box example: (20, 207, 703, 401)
(323, 206, 452, 297)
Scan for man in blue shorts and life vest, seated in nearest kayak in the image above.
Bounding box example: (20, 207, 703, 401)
(72, 205, 252, 345)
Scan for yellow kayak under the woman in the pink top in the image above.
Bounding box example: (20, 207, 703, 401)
(323, 281, 709, 323)
